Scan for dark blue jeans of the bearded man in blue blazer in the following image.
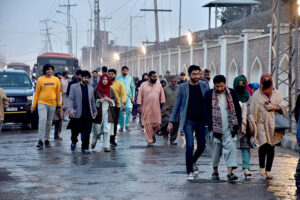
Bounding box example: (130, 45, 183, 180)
(183, 119, 205, 174)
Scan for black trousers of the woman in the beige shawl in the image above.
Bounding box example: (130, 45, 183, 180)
(258, 143, 275, 172)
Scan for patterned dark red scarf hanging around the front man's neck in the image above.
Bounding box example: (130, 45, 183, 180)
(212, 88, 238, 135)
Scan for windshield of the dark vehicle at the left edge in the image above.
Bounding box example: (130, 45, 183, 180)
(0, 72, 32, 87)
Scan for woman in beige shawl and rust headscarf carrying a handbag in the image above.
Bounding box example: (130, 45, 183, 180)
(250, 73, 287, 179)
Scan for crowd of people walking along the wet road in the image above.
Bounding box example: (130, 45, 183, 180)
(0, 64, 300, 181)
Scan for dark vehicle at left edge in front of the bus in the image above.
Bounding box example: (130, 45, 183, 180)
(0, 69, 38, 129)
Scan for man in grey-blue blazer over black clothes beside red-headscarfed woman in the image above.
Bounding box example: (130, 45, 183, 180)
(68, 71, 97, 154)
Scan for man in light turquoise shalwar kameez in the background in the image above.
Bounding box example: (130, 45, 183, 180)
(117, 66, 135, 132)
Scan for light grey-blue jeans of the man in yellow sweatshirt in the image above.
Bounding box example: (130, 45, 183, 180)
(38, 104, 56, 140)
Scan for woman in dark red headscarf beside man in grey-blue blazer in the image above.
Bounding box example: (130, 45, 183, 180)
(91, 74, 117, 152)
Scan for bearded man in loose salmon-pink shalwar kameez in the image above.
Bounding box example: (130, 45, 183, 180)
(137, 71, 166, 147)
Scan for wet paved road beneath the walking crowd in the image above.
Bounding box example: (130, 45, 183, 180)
(0, 123, 300, 200)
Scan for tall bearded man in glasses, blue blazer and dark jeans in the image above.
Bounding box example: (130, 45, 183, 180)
(168, 65, 208, 181)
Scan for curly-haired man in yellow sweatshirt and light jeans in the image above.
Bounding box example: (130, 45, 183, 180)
(31, 64, 61, 150)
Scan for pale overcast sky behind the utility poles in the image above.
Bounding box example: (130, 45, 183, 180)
(0, 0, 214, 65)
